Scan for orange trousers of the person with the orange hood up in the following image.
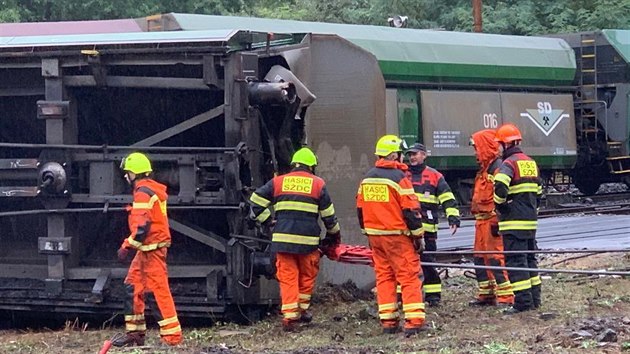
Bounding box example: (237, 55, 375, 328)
(474, 215, 514, 304)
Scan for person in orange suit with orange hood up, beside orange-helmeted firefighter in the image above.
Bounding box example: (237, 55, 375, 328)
(470, 129, 514, 306)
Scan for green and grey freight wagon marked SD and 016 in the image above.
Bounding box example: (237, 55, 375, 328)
(138, 13, 577, 199)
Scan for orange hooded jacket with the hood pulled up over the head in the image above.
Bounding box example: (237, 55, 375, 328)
(470, 129, 503, 220)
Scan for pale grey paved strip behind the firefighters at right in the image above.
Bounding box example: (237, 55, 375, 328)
(438, 215, 630, 250)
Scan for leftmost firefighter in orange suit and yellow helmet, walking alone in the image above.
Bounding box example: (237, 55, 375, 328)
(112, 152, 182, 347)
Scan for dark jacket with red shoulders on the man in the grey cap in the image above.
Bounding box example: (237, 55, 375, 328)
(409, 164, 459, 232)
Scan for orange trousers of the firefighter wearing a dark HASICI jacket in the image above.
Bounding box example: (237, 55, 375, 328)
(276, 250, 321, 323)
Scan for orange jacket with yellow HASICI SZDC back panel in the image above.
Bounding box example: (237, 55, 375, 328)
(357, 159, 424, 237)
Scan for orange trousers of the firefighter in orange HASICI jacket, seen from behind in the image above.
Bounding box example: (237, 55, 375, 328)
(368, 235, 425, 328)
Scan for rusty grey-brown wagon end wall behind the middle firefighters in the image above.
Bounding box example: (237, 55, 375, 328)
(300, 35, 385, 286)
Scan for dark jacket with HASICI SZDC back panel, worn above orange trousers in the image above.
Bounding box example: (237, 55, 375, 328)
(250, 167, 340, 254)
